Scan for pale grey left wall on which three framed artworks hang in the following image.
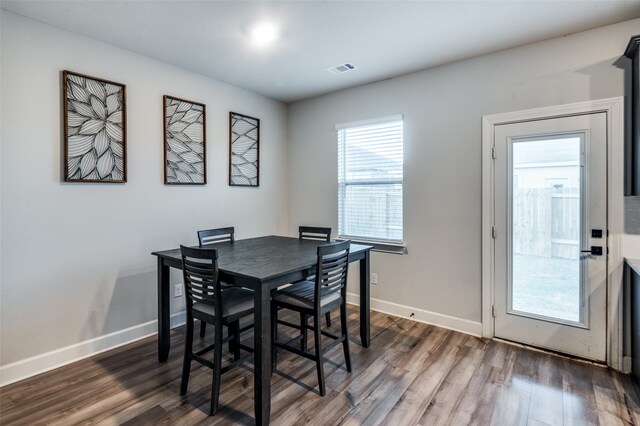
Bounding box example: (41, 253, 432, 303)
(0, 11, 288, 374)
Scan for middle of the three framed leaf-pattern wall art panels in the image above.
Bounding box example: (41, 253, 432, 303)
(163, 96, 207, 185)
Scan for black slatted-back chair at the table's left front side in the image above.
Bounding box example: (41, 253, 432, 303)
(180, 245, 254, 415)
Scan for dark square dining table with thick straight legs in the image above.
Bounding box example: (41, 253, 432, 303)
(152, 235, 373, 425)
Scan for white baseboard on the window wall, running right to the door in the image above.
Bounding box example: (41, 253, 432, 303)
(347, 293, 482, 337)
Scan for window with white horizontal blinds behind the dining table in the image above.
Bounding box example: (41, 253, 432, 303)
(336, 116, 403, 244)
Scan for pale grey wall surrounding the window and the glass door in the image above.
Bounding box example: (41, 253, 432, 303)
(288, 16, 640, 333)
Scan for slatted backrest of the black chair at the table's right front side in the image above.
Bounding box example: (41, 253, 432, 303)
(315, 240, 351, 309)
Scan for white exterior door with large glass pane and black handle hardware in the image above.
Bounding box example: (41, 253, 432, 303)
(494, 114, 607, 361)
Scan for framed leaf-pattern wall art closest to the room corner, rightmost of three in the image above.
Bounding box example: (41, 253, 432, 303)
(229, 112, 260, 186)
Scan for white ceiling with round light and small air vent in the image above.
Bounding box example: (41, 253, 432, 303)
(1, 0, 640, 102)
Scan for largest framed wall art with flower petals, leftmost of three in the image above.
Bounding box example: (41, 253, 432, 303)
(63, 71, 127, 182)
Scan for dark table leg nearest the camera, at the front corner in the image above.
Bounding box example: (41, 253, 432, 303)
(254, 286, 271, 425)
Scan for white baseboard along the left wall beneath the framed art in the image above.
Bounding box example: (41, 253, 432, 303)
(0, 311, 186, 386)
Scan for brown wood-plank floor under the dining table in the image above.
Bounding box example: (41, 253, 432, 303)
(0, 307, 640, 426)
